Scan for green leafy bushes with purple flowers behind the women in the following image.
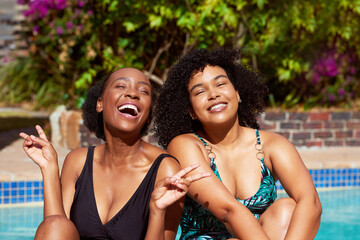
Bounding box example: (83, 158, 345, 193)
(0, 0, 360, 108)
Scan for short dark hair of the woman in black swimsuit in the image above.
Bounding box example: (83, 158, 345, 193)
(81, 69, 155, 141)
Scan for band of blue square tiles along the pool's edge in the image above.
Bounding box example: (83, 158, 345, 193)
(0, 168, 360, 204)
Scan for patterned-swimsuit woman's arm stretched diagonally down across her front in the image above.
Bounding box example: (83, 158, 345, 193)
(168, 135, 269, 239)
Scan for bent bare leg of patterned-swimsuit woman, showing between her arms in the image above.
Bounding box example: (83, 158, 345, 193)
(259, 198, 296, 240)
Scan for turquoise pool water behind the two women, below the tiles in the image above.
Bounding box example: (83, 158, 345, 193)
(0, 188, 360, 240)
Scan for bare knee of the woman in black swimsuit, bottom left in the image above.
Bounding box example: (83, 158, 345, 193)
(35, 215, 80, 240)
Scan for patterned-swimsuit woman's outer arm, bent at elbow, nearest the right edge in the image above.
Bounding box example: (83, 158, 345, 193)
(264, 133, 322, 239)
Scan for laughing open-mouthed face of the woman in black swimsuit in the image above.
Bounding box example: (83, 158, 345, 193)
(96, 68, 151, 134)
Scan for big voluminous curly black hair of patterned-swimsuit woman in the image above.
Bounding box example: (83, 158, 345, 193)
(154, 48, 268, 149)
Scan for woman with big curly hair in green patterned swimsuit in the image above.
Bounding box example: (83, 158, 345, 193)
(155, 49, 321, 240)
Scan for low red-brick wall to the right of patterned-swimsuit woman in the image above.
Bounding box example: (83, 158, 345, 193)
(259, 111, 360, 148)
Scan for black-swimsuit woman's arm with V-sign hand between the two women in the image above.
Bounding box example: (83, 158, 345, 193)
(145, 159, 209, 240)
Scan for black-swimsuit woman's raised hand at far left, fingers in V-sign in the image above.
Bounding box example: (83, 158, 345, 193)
(19, 125, 58, 169)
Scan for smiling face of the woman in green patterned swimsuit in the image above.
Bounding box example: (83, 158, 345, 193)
(188, 63, 240, 126)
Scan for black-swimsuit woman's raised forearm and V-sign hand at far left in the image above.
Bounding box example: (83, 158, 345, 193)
(20, 126, 65, 218)
